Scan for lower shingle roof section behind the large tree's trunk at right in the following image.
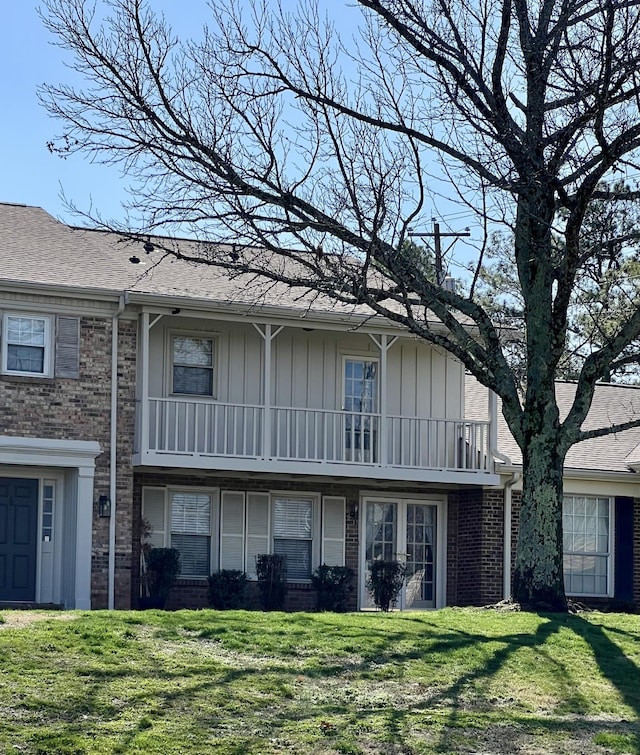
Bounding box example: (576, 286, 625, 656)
(465, 376, 640, 472)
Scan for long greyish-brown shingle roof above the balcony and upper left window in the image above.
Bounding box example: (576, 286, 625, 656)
(0, 203, 371, 316)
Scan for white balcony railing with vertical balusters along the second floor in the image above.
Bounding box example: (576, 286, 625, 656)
(134, 398, 497, 484)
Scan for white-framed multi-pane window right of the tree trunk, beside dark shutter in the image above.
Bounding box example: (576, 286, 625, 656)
(562, 496, 611, 595)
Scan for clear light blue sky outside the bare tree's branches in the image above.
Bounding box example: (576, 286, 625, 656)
(0, 0, 477, 268)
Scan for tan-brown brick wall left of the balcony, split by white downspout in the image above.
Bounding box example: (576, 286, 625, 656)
(0, 317, 136, 608)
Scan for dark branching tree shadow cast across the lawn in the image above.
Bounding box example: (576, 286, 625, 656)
(97, 614, 639, 752)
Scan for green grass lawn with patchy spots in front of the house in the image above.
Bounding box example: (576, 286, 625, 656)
(0, 609, 640, 755)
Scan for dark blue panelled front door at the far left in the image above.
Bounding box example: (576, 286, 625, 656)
(0, 477, 38, 601)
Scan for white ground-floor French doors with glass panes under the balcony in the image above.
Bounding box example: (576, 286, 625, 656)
(360, 499, 438, 609)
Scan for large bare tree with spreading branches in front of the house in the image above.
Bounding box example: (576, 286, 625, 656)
(41, 0, 640, 609)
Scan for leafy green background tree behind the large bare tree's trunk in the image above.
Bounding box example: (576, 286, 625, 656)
(476, 181, 640, 391)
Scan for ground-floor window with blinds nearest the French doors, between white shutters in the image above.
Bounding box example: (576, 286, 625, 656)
(273, 498, 313, 580)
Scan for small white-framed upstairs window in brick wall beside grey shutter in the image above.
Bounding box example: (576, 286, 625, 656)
(2, 315, 51, 375)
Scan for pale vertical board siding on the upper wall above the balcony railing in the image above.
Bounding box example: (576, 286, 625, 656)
(149, 317, 464, 418)
